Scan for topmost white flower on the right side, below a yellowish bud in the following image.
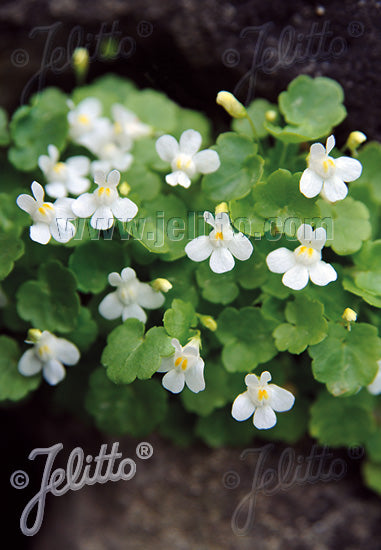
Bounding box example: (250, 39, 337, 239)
(300, 136, 362, 202)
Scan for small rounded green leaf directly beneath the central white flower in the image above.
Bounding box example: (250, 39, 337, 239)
(196, 261, 241, 305)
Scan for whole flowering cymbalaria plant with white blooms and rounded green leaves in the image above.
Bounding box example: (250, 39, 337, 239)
(0, 75, 381, 491)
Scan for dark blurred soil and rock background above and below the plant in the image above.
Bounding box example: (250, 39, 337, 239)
(0, 0, 381, 550)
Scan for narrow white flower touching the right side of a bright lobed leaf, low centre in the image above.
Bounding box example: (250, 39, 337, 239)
(157, 338, 205, 393)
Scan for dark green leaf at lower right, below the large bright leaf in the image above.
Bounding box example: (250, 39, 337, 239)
(310, 391, 375, 447)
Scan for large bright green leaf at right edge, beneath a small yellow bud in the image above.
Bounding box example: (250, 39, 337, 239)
(308, 323, 381, 396)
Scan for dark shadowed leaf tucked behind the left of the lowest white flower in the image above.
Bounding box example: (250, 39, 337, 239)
(196, 407, 252, 447)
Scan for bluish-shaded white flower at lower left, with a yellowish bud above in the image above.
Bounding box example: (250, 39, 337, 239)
(18, 330, 80, 386)
